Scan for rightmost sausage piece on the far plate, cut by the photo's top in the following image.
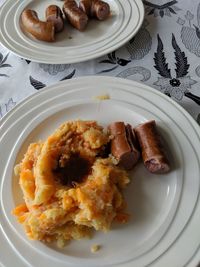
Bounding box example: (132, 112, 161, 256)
(79, 0, 110, 20)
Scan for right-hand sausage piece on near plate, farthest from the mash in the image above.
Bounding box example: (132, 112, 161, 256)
(135, 120, 170, 173)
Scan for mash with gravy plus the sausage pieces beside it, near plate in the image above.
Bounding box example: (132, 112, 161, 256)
(13, 120, 169, 247)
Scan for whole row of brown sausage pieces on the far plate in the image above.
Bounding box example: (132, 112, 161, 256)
(21, 0, 110, 42)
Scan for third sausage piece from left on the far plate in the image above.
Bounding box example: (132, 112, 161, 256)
(63, 0, 88, 31)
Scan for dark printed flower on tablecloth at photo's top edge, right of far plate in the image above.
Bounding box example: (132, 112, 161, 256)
(143, 0, 181, 18)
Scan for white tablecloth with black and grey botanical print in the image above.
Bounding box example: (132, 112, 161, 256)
(0, 0, 200, 123)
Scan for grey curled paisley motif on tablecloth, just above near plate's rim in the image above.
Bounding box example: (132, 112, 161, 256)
(116, 66, 151, 82)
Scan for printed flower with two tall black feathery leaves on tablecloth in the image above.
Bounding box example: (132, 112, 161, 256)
(154, 34, 200, 105)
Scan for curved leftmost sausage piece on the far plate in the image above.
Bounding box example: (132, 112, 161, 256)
(21, 9, 55, 42)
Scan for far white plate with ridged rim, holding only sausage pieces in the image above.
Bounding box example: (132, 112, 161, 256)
(0, 0, 144, 64)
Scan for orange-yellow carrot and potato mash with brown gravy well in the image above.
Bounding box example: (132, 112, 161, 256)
(13, 121, 129, 247)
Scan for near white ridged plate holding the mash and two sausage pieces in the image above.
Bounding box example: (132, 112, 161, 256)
(0, 77, 200, 267)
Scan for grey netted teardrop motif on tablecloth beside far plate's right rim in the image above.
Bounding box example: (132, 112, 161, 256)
(126, 19, 152, 60)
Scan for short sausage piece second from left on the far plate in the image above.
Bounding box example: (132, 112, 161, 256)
(46, 5, 64, 32)
